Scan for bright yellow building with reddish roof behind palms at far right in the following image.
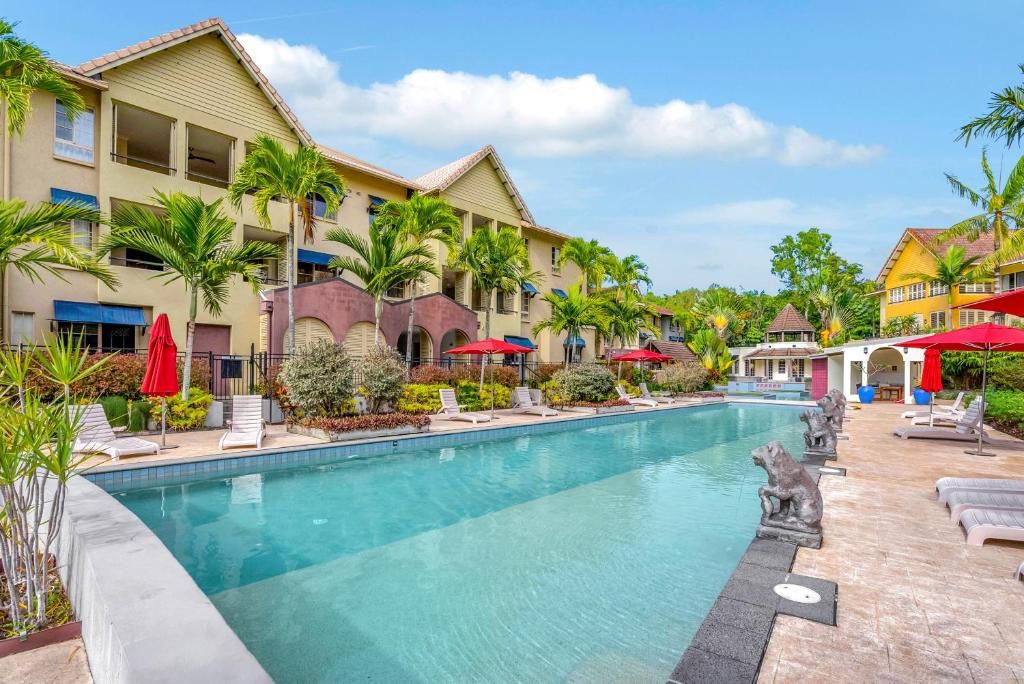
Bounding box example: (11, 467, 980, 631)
(876, 228, 991, 330)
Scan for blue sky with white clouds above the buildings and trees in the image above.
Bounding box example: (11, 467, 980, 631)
(16, 0, 1024, 293)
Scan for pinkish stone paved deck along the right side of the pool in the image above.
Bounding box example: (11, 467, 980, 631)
(759, 404, 1024, 682)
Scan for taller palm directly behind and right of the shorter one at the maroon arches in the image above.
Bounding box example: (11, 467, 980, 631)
(377, 193, 462, 368)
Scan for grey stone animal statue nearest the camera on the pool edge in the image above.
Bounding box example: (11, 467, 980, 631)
(751, 441, 822, 549)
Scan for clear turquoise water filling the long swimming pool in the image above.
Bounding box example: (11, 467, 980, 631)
(115, 404, 802, 682)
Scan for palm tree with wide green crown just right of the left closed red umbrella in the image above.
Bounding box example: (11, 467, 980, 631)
(99, 190, 281, 401)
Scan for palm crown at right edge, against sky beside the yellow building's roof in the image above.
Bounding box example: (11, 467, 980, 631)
(936, 151, 1024, 278)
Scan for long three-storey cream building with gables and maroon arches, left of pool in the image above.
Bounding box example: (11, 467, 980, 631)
(0, 18, 594, 360)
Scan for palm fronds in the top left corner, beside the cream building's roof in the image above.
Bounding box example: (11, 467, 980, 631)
(0, 18, 85, 135)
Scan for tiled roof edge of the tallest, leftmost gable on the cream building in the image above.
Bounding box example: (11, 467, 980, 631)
(74, 16, 313, 145)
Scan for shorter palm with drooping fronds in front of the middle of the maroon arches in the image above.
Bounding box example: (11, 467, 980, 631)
(325, 219, 438, 346)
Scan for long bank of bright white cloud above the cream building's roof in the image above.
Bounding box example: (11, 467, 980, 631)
(239, 34, 884, 166)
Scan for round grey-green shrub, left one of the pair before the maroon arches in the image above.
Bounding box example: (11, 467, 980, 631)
(280, 340, 355, 417)
